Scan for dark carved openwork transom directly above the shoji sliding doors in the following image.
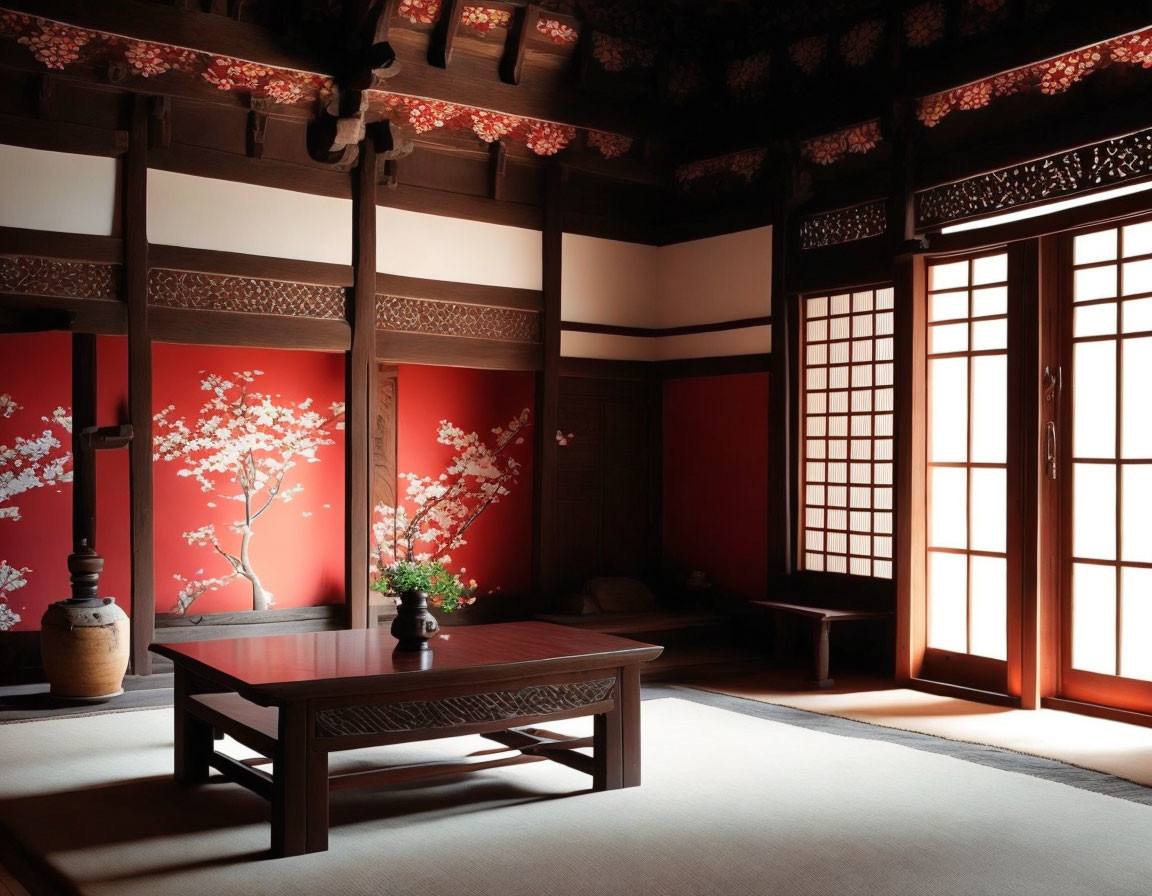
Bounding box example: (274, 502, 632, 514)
(916, 129, 1152, 228)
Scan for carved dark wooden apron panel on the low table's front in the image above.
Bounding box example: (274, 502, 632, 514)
(316, 677, 616, 737)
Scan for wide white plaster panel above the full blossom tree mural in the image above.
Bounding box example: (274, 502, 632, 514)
(147, 168, 353, 265)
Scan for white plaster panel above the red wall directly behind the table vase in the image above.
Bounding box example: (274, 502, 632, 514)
(376, 206, 544, 289)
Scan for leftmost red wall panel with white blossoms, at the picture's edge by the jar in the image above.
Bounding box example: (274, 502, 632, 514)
(0, 333, 71, 631)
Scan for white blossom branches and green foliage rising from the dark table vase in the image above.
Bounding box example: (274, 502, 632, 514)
(370, 408, 531, 612)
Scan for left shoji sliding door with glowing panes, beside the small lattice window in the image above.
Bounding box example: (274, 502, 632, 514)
(924, 251, 1015, 690)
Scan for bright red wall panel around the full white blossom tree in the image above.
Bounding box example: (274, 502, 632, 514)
(153, 344, 344, 615)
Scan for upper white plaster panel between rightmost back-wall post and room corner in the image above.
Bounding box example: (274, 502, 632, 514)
(560, 234, 658, 327)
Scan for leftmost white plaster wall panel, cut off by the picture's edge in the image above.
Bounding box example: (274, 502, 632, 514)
(0, 144, 119, 236)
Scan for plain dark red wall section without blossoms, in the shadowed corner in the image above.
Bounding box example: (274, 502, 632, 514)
(664, 373, 768, 598)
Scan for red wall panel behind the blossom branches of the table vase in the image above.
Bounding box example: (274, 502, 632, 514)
(396, 364, 536, 600)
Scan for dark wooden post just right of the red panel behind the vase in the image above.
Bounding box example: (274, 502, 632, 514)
(532, 167, 563, 608)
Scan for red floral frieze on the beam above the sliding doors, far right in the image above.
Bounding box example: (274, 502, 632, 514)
(916, 28, 1152, 128)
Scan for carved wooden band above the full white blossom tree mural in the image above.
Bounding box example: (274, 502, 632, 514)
(147, 267, 344, 320)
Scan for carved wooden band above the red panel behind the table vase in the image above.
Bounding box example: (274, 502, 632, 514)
(376, 295, 540, 342)
